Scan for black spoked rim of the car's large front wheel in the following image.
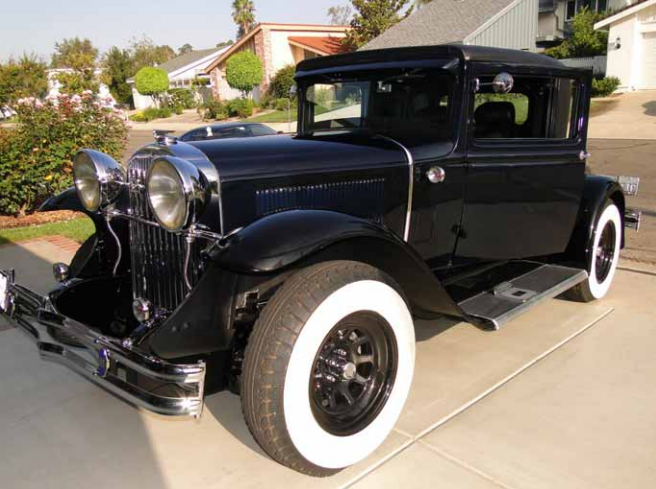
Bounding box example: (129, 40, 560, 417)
(310, 311, 398, 436)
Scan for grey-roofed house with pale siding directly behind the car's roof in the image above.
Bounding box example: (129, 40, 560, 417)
(361, 0, 538, 51)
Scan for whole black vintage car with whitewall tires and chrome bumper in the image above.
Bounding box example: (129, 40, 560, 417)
(0, 45, 638, 476)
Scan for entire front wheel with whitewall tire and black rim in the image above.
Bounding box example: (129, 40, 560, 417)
(241, 261, 415, 476)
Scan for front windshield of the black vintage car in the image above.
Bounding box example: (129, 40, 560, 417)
(303, 69, 454, 142)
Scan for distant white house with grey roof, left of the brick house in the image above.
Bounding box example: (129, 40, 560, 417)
(127, 47, 229, 110)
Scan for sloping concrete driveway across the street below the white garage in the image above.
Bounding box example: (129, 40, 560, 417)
(588, 90, 656, 139)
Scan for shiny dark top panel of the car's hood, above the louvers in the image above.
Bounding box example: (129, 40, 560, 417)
(190, 135, 407, 182)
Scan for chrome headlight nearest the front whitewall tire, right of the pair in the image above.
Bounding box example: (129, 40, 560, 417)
(146, 156, 210, 232)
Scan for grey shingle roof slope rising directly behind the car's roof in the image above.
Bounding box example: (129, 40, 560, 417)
(361, 0, 515, 50)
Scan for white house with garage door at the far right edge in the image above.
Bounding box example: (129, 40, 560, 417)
(595, 0, 656, 91)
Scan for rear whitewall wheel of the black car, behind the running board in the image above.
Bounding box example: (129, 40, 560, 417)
(566, 201, 622, 302)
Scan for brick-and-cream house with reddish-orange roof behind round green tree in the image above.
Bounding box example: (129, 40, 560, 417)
(207, 23, 349, 101)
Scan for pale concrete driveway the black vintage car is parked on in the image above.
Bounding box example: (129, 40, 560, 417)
(0, 242, 656, 489)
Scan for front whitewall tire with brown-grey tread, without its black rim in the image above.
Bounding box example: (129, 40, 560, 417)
(242, 261, 415, 476)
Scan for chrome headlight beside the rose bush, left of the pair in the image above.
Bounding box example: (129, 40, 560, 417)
(73, 149, 125, 212)
